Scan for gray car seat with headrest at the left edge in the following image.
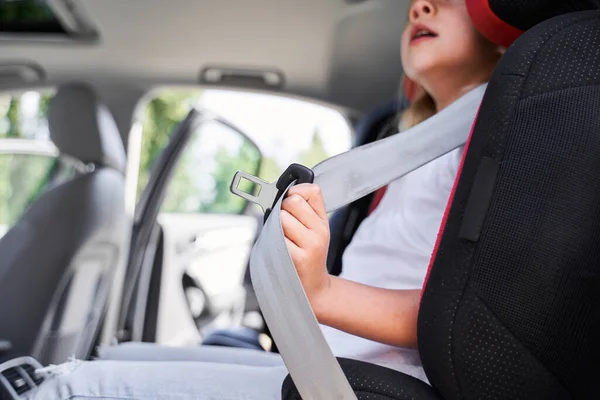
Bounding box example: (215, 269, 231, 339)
(0, 83, 129, 364)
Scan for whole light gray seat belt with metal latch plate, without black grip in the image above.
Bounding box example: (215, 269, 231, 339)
(231, 85, 486, 400)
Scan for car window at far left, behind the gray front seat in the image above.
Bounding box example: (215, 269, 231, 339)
(0, 91, 59, 236)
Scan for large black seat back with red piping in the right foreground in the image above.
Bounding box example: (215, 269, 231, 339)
(418, 10, 600, 400)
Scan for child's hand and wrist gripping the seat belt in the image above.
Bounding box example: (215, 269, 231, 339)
(281, 184, 330, 313)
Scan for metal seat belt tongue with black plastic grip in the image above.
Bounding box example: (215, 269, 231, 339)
(230, 164, 315, 222)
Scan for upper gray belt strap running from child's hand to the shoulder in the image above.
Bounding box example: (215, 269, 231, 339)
(313, 85, 486, 212)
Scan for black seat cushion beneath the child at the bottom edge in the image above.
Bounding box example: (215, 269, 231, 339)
(281, 358, 441, 400)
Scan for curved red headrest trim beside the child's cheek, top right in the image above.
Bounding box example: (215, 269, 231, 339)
(466, 0, 523, 47)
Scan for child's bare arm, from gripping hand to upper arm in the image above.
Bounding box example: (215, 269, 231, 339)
(281, 184, 420, 347)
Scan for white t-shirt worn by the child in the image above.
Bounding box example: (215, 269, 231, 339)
(322, 148, 463, 379)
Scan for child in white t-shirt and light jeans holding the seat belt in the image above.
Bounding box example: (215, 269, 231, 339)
(33, 0, 502, 400)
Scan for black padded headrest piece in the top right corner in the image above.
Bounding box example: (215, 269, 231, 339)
(490, 0, 600, 31)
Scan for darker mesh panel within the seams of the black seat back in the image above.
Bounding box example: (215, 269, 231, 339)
(472, 87, 600, 392)
